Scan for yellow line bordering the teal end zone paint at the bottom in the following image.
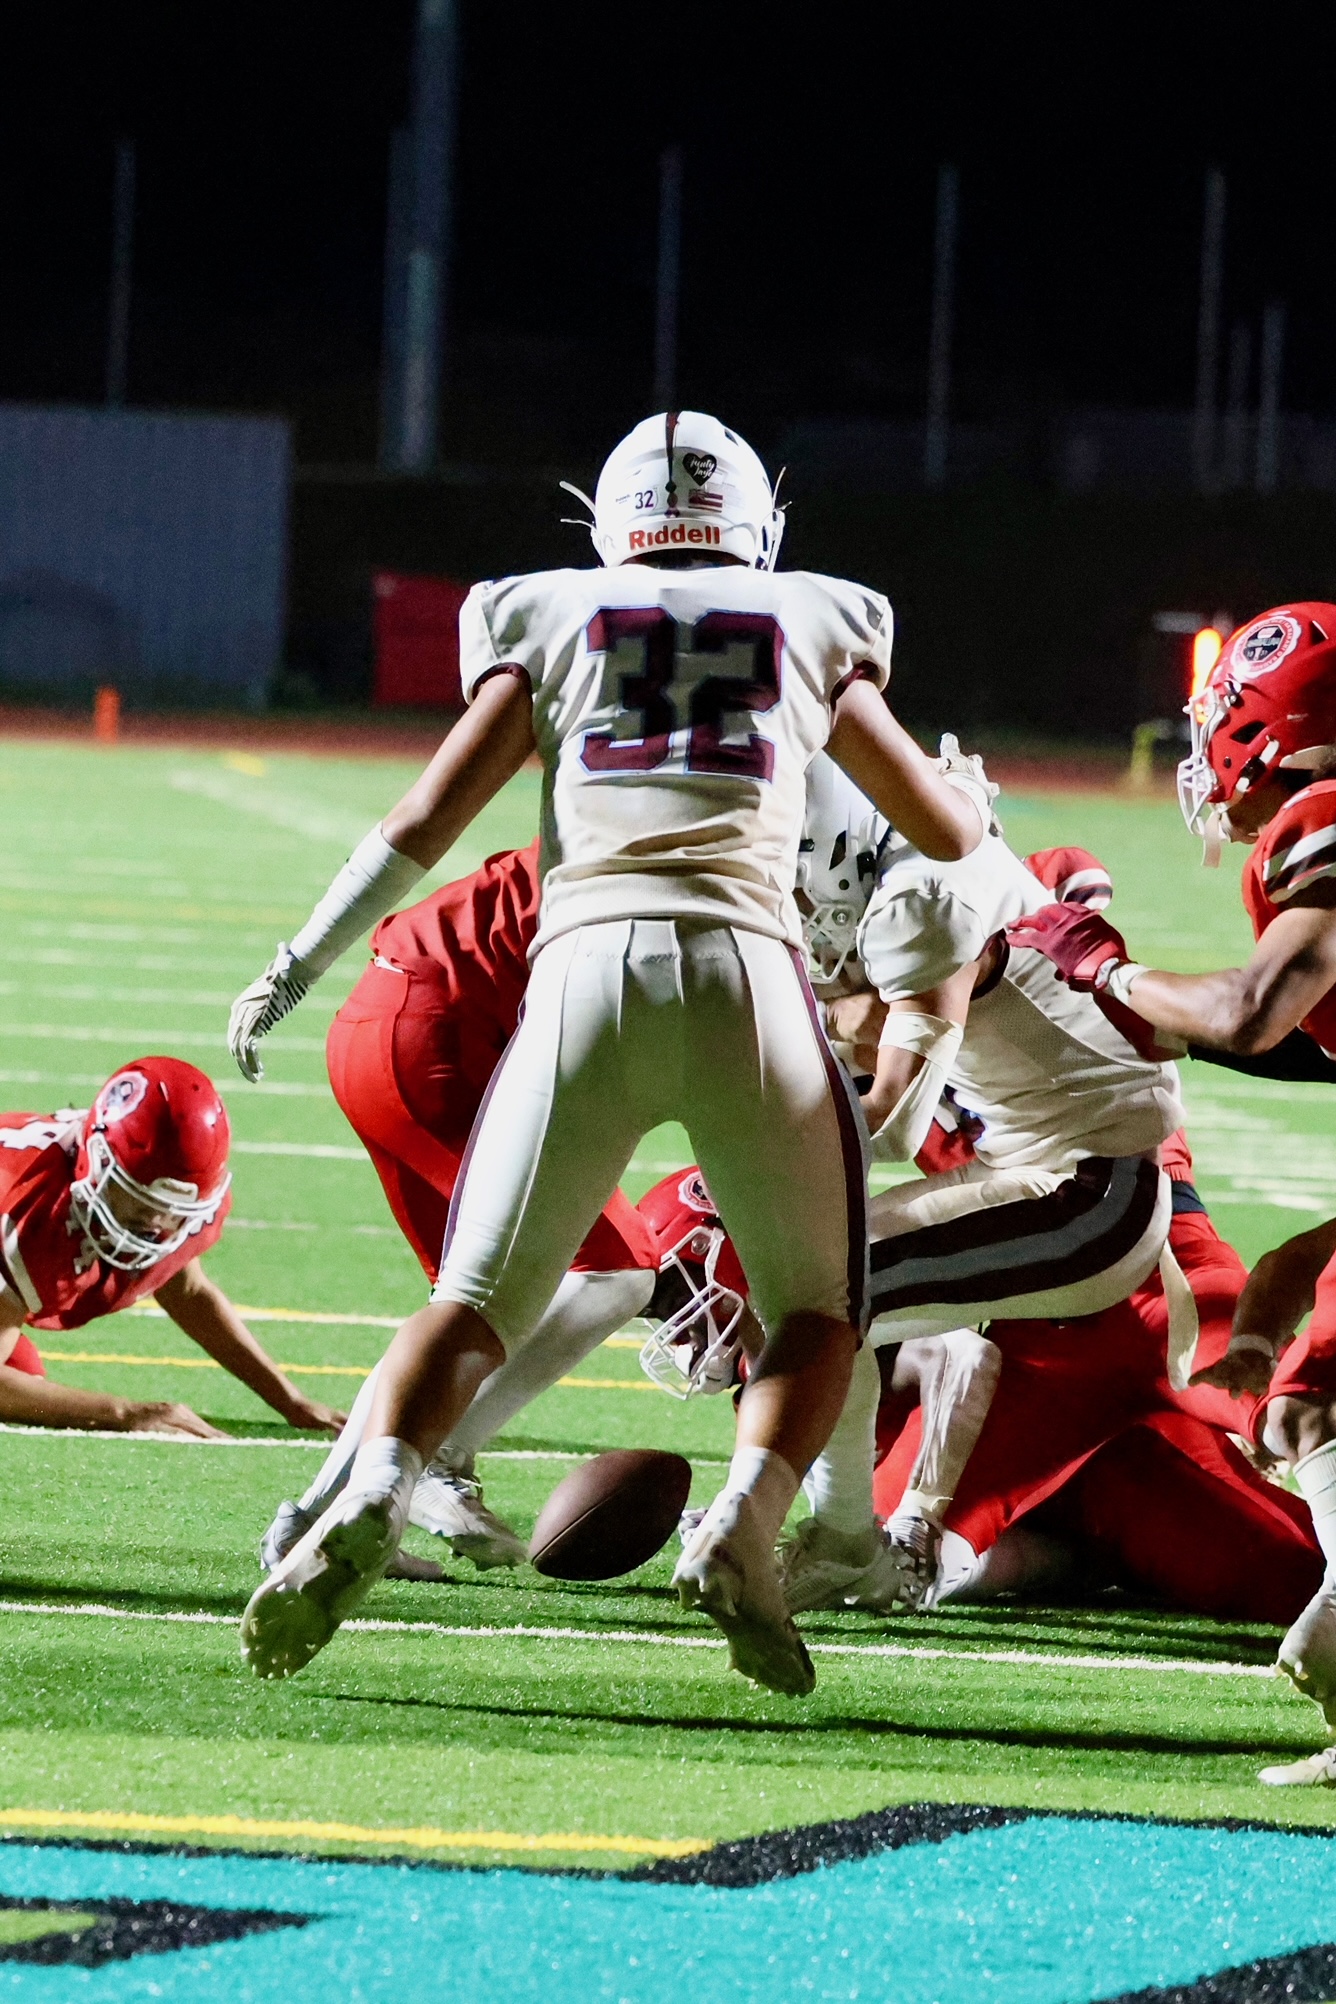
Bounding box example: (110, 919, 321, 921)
(0, 1810, 709, 1858)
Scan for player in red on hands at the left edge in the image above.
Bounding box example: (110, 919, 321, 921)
(0, 1058, 343, 1439)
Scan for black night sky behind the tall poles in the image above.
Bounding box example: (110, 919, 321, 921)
(0, 0, 1336, 463)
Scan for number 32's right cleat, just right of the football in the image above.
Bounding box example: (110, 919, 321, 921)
(673, 1497, 817, 1697)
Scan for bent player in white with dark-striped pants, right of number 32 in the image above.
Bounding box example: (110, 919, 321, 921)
(783, 772, 1196, 1609)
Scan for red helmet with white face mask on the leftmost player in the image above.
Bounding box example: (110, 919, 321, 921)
(70, 1058, 232, 1273)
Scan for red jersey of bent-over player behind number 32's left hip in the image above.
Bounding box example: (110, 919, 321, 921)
(371, 842, 541, 1044)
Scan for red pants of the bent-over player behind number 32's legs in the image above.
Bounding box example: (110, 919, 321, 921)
(326, 962, 659, 1283)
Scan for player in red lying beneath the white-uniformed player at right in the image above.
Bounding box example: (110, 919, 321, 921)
(875, 1142, 1322, 1651)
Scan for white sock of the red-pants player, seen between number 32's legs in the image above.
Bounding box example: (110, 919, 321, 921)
(439, 1267, 655, 1469)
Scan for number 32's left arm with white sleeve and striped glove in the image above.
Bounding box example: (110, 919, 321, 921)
(228, 667, 533, 1080)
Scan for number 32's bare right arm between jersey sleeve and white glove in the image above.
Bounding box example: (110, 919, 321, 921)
(825, 677, 985, 862)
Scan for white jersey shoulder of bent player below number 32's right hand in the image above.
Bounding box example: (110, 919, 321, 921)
(857, 836, 1050, 1002)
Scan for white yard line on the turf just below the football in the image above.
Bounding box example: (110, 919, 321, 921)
(0, 1601, 1276, 1679)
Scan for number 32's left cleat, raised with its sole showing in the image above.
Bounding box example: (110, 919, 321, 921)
(240, 1489, 403, 1677)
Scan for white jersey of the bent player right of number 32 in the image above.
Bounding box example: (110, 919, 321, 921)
(859, 836, 1186, 1170)
